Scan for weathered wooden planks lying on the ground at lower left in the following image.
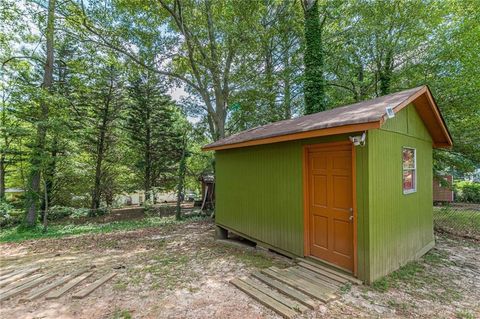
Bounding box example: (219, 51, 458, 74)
(0, 267, 116, 302)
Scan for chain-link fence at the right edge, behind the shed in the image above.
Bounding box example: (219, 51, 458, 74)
(433, 203, 480, 240)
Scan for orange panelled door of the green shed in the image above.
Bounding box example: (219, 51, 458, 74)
(307, 144, 354, 272)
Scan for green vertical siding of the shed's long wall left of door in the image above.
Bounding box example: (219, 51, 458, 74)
(215, 135, 366, 258)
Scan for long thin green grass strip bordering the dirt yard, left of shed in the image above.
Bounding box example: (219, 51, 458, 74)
(0, 216, 209, 242)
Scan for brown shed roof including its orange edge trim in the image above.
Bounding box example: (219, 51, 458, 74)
(203, 86, 452, 150)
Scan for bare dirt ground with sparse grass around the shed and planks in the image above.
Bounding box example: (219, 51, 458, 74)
(0, 221, 480, 319)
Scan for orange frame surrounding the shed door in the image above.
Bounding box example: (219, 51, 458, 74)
(302, 141, 358, 277)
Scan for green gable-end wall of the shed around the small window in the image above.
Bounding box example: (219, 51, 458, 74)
(365, 105, 434, 282)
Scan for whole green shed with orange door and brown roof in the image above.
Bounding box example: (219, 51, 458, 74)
(204, 86, 452, 283)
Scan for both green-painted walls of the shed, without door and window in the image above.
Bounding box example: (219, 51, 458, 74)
(215, 106, 433, 282)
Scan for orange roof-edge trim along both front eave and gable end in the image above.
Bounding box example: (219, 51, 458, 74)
(202, 86, 453, 151)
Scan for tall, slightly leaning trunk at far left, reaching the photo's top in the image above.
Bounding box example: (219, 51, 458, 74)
(26, 0, 55, 226)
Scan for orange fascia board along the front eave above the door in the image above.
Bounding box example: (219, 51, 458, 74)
(202, 121, 381, 151)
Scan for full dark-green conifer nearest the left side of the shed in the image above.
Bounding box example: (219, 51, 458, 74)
(126, 70, 184, 201)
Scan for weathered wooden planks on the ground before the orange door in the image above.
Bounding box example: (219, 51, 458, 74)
(231, 258, 362, 318)
